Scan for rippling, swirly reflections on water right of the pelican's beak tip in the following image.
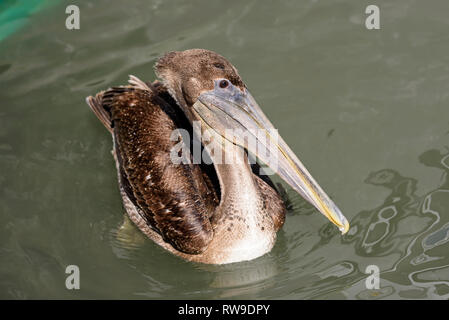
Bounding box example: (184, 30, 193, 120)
(343, 150, 449, 299)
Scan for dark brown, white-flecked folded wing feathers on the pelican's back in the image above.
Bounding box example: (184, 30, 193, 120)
(94, 87, 216, 254)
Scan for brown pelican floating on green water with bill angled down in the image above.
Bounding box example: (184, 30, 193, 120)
(86, 49, 349, 264)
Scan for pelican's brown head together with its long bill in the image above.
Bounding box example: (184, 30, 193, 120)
(155, 49, 349, 233)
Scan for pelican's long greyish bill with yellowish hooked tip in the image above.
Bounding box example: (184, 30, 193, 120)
(192, 80, 349, 234)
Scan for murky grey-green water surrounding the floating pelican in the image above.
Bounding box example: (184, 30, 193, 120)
(0, 0, 449, 299)
